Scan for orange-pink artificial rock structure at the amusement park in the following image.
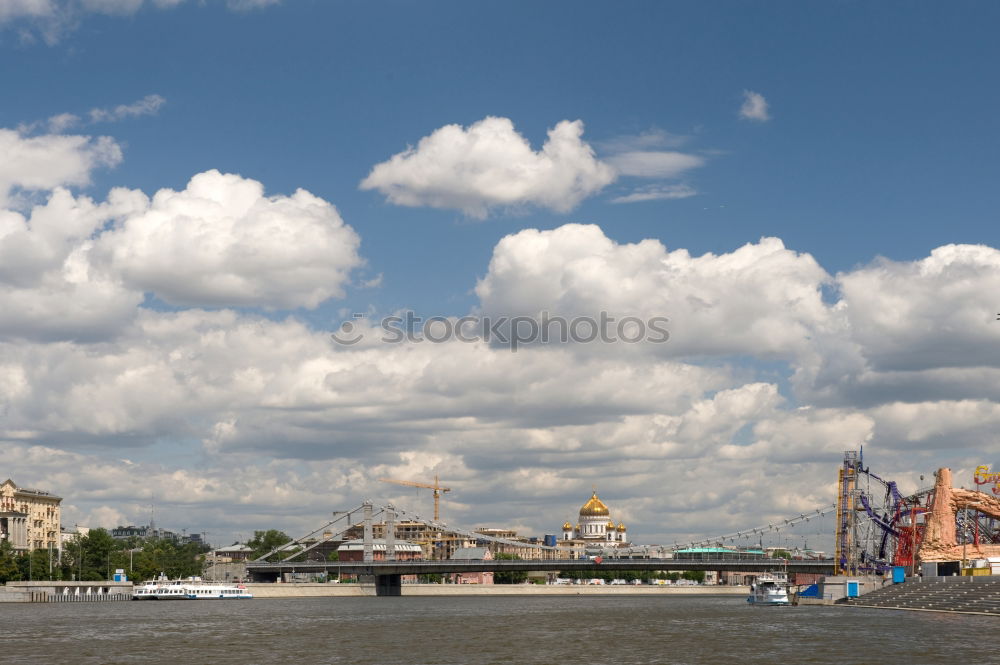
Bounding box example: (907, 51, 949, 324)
(918, 469, 1000, 561)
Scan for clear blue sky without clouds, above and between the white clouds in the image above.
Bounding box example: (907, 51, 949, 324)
(9, 1, 1000, 313)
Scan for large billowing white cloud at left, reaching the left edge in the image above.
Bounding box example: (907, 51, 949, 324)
(0, 171, 363, 341)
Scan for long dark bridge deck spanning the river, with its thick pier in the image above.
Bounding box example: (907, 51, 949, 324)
(247, 558, 834, 596)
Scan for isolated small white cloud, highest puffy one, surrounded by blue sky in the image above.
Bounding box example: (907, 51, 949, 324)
(361, 117, 615, 218)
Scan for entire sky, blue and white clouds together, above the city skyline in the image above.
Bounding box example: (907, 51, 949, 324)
(0, 0, 1000, 547)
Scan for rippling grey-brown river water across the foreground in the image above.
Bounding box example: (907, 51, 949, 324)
(0, 596, 1000, 665)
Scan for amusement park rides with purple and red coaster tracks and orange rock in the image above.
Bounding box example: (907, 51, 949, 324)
(836, 451, 1000, 574)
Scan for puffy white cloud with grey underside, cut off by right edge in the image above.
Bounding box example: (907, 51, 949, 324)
(795, 245, 1000, 406)
